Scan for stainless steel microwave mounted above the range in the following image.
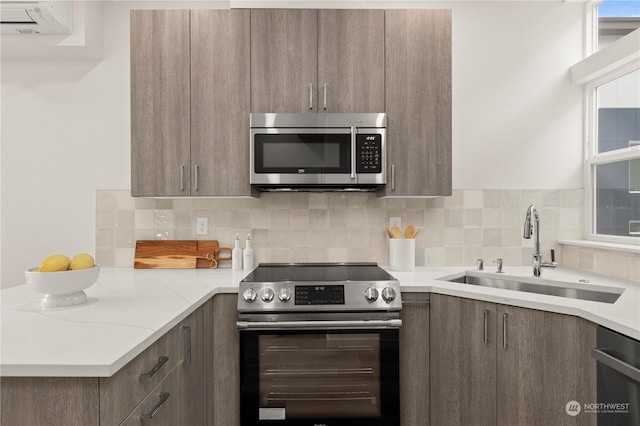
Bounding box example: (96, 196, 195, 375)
(250, 113, 387, 191)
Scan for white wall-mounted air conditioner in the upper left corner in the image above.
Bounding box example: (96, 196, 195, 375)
(0, 0, 73, 35)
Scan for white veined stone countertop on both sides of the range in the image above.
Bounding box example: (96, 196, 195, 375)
(0, 266, 640, 377)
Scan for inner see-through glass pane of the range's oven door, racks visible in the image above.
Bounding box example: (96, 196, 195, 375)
(258, 333, 382, 419)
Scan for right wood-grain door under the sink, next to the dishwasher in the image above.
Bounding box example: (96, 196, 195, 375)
(497, 305, 597, 426)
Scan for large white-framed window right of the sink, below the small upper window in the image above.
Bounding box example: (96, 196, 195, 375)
(586, 50, 640, 244)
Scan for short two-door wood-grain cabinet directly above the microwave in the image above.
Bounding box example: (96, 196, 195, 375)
(251, 9, 384, 112)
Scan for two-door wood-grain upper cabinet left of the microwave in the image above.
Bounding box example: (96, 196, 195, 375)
(131, 10, 251, 196)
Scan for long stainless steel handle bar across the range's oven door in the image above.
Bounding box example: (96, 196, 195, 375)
(236, 319, 402, 330)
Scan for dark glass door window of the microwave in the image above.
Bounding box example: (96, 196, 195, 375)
(254, 133, 351, 173)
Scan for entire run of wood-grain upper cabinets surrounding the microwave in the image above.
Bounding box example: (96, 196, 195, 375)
(131, 9, 451, 197)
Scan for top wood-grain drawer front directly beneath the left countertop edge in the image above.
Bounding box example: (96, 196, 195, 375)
(100, 327, 180, 426)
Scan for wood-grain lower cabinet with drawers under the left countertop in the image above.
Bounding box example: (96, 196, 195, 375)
(0, 300, 210, 426)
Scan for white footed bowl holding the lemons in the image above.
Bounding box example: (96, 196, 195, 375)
(24, 265, 100, 308)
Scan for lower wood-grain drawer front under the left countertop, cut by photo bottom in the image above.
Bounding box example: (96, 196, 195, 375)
(121, 366, 182, 426)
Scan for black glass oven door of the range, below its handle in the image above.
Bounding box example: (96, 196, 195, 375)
(240, 327, 400, 426)
